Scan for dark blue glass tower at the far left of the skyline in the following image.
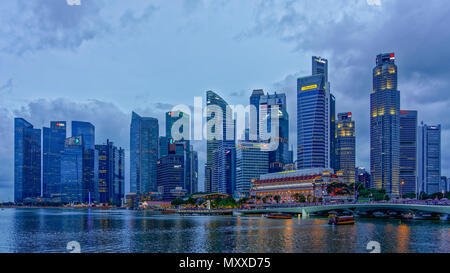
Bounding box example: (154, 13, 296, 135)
(14, 118, 41, 202)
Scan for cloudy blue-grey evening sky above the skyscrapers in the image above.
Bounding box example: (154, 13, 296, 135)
(0, 0, 450, 201)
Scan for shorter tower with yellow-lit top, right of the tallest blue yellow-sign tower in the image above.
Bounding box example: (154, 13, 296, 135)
(335, 113, 356, 184)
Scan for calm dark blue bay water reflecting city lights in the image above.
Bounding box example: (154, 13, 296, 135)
(0, 209, 450, 253)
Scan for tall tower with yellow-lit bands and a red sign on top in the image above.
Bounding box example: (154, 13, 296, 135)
(370, 53, 400, 197)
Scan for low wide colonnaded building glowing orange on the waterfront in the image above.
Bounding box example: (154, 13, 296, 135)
(250, 168, 343, 202)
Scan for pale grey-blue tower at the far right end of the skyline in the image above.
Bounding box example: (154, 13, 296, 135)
(418, 122, 441, 194)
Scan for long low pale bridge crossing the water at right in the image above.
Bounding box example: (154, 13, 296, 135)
(238, 203, 450, 217)
